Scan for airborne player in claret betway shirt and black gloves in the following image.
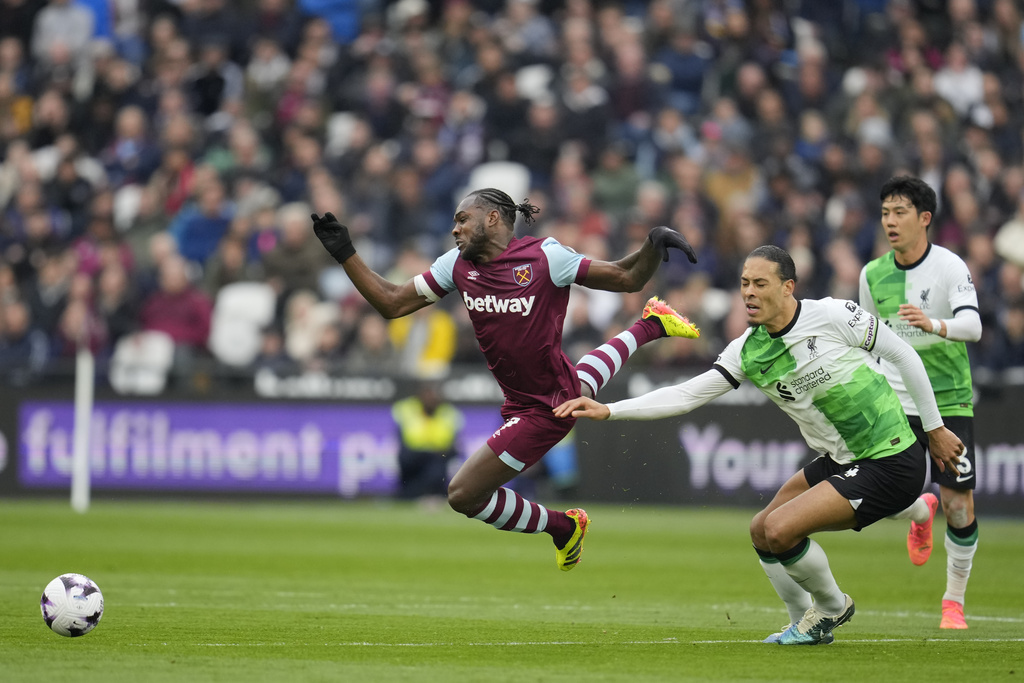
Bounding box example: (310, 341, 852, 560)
(312, 188, 699, 571)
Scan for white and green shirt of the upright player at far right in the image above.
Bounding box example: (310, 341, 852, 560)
(860, 245, 978, 416)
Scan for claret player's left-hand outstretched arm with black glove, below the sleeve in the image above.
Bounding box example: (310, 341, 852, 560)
(312, 213, 430, 318)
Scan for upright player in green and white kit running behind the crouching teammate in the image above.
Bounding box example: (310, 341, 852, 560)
(860, 176, 981, 629)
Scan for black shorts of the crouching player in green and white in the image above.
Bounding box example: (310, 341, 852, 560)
(803, 441, 928, 531)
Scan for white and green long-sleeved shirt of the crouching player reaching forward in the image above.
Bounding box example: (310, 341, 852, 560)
(608, 299, 942, 464)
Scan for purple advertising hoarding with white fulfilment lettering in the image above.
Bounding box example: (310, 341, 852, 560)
(17, 401, 501, 498)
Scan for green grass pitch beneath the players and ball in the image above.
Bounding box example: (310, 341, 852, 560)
(0, 500, 1024, 683)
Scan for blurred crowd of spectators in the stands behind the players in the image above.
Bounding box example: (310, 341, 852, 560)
(0, 0, 1024, 393)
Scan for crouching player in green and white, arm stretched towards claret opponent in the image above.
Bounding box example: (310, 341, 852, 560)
(555, 245, 964, 645)
